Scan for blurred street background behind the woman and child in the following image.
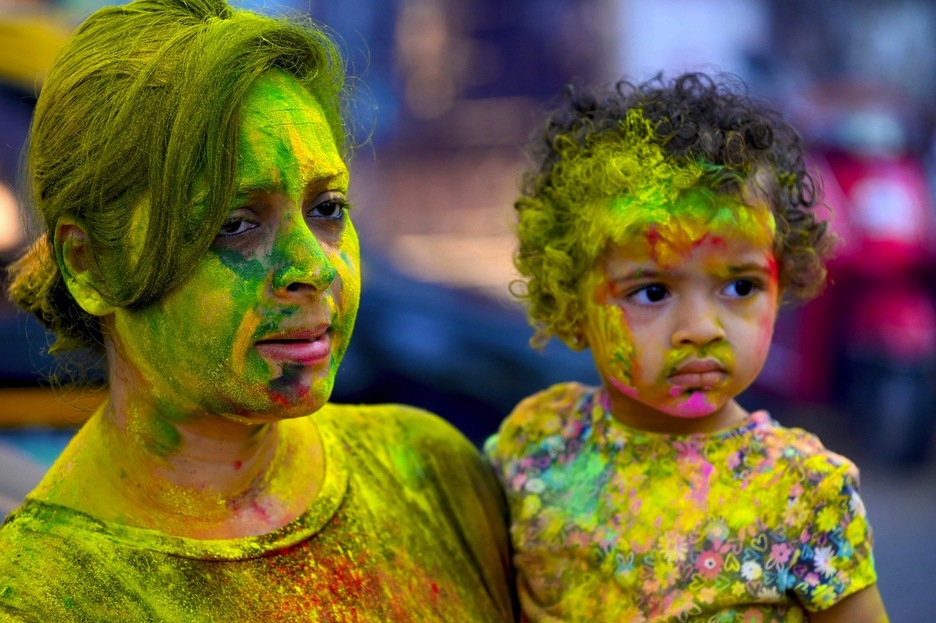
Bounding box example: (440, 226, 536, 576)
(0, 0, 936, 621)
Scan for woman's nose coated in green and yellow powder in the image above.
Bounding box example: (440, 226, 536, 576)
(273, 219, 338, 292)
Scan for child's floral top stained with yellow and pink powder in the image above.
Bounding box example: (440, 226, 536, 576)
(485, 383, 876, 623)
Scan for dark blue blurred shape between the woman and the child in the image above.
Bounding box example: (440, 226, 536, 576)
(333, 251, 598, 444)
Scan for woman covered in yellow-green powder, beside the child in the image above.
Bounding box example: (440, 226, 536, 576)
(0, 0, 513, 622)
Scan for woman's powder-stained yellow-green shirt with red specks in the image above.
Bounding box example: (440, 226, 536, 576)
(0, 405, 514, 623)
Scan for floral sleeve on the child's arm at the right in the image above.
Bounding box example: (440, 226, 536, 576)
(789, 457, 877, 612)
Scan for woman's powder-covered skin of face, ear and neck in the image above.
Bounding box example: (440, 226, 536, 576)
(40, 72, 360, 538)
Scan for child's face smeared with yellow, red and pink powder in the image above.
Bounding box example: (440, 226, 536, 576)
(582, 198, 778, 434)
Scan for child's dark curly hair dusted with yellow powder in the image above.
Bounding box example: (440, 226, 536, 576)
(514, 73, 833, 348)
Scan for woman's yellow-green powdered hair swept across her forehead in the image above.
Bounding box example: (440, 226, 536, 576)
(10, 0, 348, 351)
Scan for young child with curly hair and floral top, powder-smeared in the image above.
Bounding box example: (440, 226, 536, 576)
(486, 74, 887, 623)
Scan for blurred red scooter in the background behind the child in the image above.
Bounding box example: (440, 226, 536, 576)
(763, 89, 936, 465)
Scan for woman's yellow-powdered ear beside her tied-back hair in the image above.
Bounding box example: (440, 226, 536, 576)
(55, 217, 115, 316)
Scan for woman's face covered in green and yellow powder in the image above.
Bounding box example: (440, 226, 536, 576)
(109, 72, 360, 421)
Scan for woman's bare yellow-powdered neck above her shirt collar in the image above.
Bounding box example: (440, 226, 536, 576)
(37, 387, 324, 539)
